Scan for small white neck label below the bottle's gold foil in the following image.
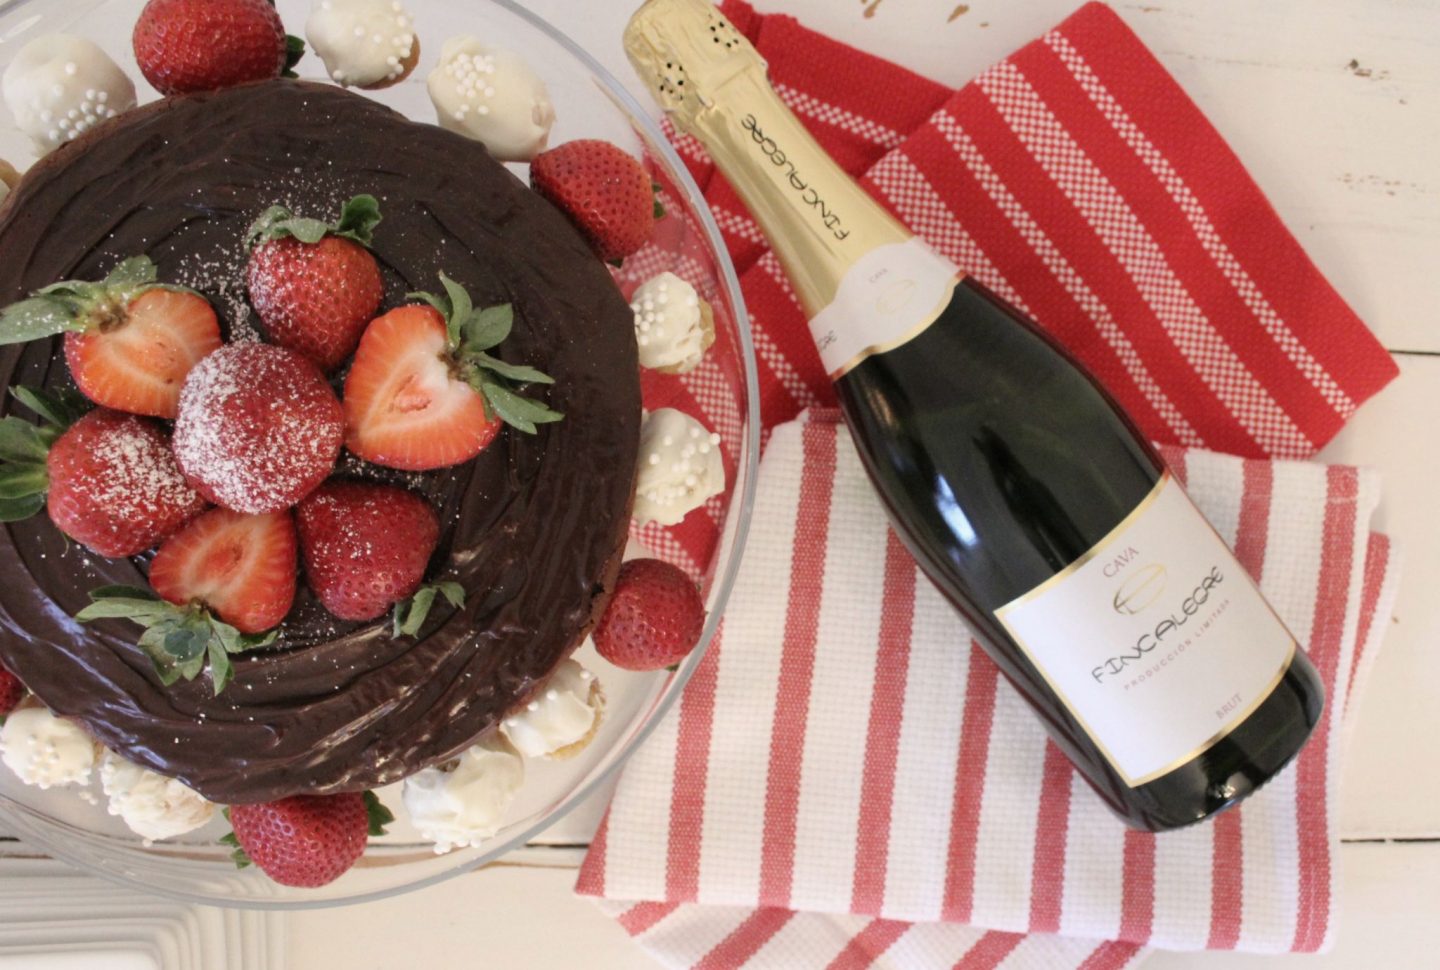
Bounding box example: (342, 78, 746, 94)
(811, 237, 960, 380)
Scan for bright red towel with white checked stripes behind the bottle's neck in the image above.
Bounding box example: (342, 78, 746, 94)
(621, 0, 1398, 573)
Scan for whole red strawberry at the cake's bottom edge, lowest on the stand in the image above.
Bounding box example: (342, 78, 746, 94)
(225, 792, 393, 888)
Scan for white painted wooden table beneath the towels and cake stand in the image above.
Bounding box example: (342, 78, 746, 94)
(5, 0, 1440, 970)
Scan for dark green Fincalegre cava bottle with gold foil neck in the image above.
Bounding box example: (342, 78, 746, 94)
(625, 0, 1323, 830)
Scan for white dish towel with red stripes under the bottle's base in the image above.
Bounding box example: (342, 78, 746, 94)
(577, 412, 1395, 970)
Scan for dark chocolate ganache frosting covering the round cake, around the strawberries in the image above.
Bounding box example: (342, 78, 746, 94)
(0, 81, 641, 803)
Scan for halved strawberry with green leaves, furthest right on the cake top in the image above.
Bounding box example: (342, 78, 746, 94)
(343, 273, 563, 471)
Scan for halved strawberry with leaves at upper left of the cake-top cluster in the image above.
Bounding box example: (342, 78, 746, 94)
(0, 256, 220, 417)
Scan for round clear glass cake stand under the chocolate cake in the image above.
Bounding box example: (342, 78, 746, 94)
(0, 0, 759, 910)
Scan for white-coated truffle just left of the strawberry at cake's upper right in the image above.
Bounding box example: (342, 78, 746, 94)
(426, 36, 554, 161)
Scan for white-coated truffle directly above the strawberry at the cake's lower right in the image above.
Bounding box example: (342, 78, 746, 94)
(635, 407, 724, 525)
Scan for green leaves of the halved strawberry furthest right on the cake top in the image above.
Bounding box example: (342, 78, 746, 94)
(408, 273, 564, 437)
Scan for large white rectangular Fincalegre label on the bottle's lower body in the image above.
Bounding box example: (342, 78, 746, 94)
(995, 473, 1295, 787)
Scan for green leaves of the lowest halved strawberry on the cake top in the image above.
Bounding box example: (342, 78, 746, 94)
(75, 586, 279, 694)
